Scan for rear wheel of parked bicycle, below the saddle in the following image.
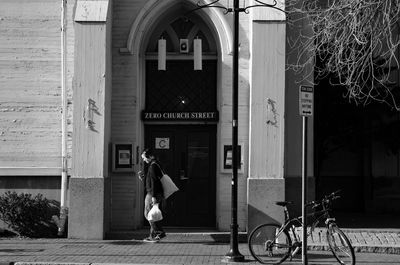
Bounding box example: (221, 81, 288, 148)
(248, 224, 292, 264)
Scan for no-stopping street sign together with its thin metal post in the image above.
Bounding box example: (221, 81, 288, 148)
(299, 86, 314, 265)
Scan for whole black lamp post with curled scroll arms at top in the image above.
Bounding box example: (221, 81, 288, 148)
(191, 0, 284, 262)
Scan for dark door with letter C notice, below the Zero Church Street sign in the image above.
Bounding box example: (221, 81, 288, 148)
(145, 125, 216, 227)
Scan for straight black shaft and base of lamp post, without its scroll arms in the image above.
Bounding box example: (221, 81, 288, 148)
(222, 0, 244, 262)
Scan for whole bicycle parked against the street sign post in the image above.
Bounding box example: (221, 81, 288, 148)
(248, 191, 356, 265)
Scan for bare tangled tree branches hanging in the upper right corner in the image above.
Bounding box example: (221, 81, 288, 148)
(286, 0, 400, 111)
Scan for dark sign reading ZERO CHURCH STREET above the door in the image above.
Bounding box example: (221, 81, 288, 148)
(142, 111, 219, 121)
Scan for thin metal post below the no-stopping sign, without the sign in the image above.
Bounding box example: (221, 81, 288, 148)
(301, 116, 308, 265)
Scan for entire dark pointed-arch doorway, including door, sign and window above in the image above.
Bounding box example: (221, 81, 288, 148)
(142, 12, 218, 227)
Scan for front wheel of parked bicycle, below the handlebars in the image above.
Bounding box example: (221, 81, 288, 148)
(326, 224, 356, 265)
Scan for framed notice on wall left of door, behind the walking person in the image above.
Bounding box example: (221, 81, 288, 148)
(112, 143, 133, 172)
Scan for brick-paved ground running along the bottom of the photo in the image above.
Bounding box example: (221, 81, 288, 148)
(0, 239, 400, 265)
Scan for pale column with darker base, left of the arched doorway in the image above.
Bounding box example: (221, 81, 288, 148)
(68, 1, 111, 239)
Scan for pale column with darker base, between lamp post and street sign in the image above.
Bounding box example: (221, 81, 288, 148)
(247, 4, 286, 232)
